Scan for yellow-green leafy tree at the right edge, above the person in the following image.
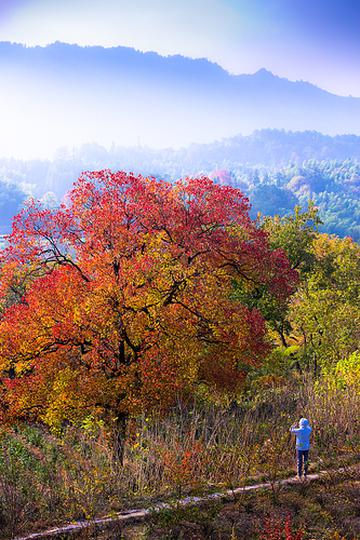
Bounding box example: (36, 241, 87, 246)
(289, 234, 360, 374)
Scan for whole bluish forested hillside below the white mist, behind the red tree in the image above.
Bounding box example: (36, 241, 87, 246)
(0, 130, 360, 240)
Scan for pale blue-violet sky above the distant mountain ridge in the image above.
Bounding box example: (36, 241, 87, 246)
(0, 0, 360, 96)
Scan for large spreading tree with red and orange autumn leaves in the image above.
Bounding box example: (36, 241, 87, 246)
(0, 170, 297, 454)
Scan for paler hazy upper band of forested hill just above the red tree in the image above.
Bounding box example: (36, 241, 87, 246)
(0, 129, 360, 198)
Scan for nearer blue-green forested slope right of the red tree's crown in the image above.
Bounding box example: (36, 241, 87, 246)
(232, 160, 360, 241)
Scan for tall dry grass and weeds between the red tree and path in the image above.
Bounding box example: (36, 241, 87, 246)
(0, 379, 360, 538)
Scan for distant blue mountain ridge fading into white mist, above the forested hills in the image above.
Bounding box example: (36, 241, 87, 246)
(0, 43, 360, 157)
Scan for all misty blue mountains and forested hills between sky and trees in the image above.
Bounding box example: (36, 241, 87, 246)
(0, 43, 360, 239)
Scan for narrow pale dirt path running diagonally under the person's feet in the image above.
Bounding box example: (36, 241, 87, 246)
(14, 465, 358, 540)
